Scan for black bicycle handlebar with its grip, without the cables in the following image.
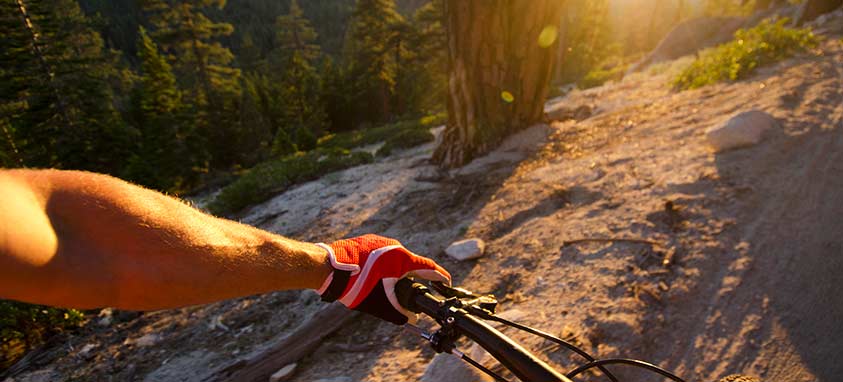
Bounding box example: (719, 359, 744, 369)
(395, 279, 571, 382)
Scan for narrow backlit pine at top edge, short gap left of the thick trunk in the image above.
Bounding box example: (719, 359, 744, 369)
(346, 0, 404, 122)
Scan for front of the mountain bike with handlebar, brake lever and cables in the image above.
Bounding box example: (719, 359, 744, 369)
(395, 278, 760, 382)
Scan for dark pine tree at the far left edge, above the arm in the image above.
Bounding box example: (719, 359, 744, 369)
(0, 0, 131, 174)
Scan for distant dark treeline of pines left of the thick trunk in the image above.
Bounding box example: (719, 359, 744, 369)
(0, 0, 445, 192)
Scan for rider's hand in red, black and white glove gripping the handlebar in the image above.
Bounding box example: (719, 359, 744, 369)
(317, 235, 451, 325)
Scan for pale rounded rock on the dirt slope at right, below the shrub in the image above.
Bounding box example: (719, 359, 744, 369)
(705, 110, 778, 152)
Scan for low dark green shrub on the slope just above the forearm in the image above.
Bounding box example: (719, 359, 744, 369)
(208, 148, 372, 215)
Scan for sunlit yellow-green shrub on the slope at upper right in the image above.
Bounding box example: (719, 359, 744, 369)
(673, 18, 817, 89)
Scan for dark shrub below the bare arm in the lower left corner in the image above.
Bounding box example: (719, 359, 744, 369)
(0, 300, 85, 371)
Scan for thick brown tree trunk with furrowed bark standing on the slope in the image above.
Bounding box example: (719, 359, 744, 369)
(433, 0, 563, 167)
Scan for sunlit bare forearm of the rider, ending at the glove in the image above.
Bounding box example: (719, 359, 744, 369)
(0, 170, 329, 310)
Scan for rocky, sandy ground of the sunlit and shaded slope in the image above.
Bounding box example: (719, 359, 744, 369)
(6, 11, 843, 381)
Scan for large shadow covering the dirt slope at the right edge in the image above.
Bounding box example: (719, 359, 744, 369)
(648, 106, 843, 381)
